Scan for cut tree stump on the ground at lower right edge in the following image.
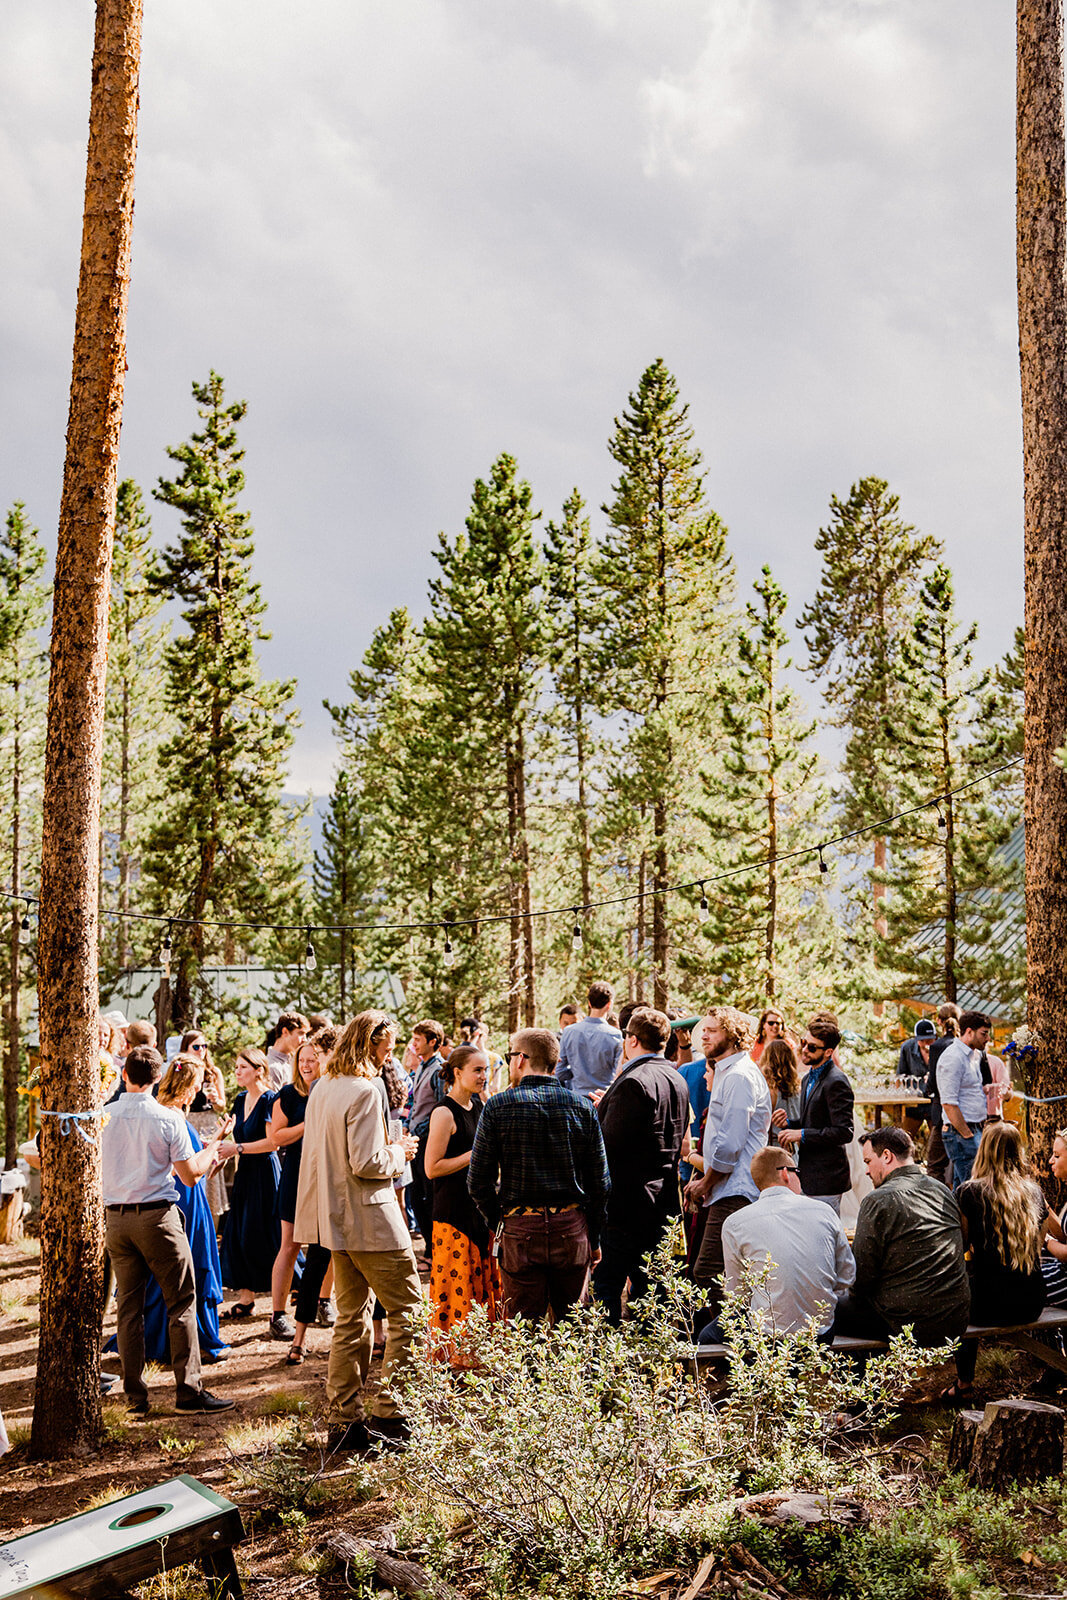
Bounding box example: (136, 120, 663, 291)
(949, 1400, 1064, 1488)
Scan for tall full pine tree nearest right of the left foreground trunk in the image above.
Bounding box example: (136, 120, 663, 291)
(144, 371, 302, 1027)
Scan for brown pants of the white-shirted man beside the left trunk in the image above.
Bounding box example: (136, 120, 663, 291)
(106, 1205, 202, 1400)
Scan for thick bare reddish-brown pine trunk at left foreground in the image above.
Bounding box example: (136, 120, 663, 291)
(30, 0, 141, 1456)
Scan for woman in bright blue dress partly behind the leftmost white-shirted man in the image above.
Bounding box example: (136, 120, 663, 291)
(131, 1054, 230, 1366)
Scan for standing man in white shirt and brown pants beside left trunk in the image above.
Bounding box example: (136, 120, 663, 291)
(101, 1045, 234, 1416)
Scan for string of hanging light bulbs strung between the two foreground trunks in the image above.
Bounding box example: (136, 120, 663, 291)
(0, 755, 1022, 953)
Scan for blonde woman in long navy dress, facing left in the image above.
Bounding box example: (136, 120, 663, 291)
(219, 1045, 282, 1322)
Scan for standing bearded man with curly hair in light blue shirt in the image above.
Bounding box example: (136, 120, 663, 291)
(685, 1005, 771, 1322)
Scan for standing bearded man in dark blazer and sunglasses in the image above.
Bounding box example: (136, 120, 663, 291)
(777, 1011, 854, 1211)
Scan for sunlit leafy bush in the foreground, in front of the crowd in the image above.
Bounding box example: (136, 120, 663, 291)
(402, 1254, 915, 1597)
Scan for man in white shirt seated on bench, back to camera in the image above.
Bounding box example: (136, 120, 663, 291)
(699, 1144, 856, 1344)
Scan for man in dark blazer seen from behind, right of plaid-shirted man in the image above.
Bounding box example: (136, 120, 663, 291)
(592, 1006, 689, 1326)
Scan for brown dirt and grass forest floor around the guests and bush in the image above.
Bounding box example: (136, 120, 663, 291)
(0, 1238, 1067, 1600)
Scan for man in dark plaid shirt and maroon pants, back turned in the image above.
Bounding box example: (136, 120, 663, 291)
(467, 1027, 611, 1322)
